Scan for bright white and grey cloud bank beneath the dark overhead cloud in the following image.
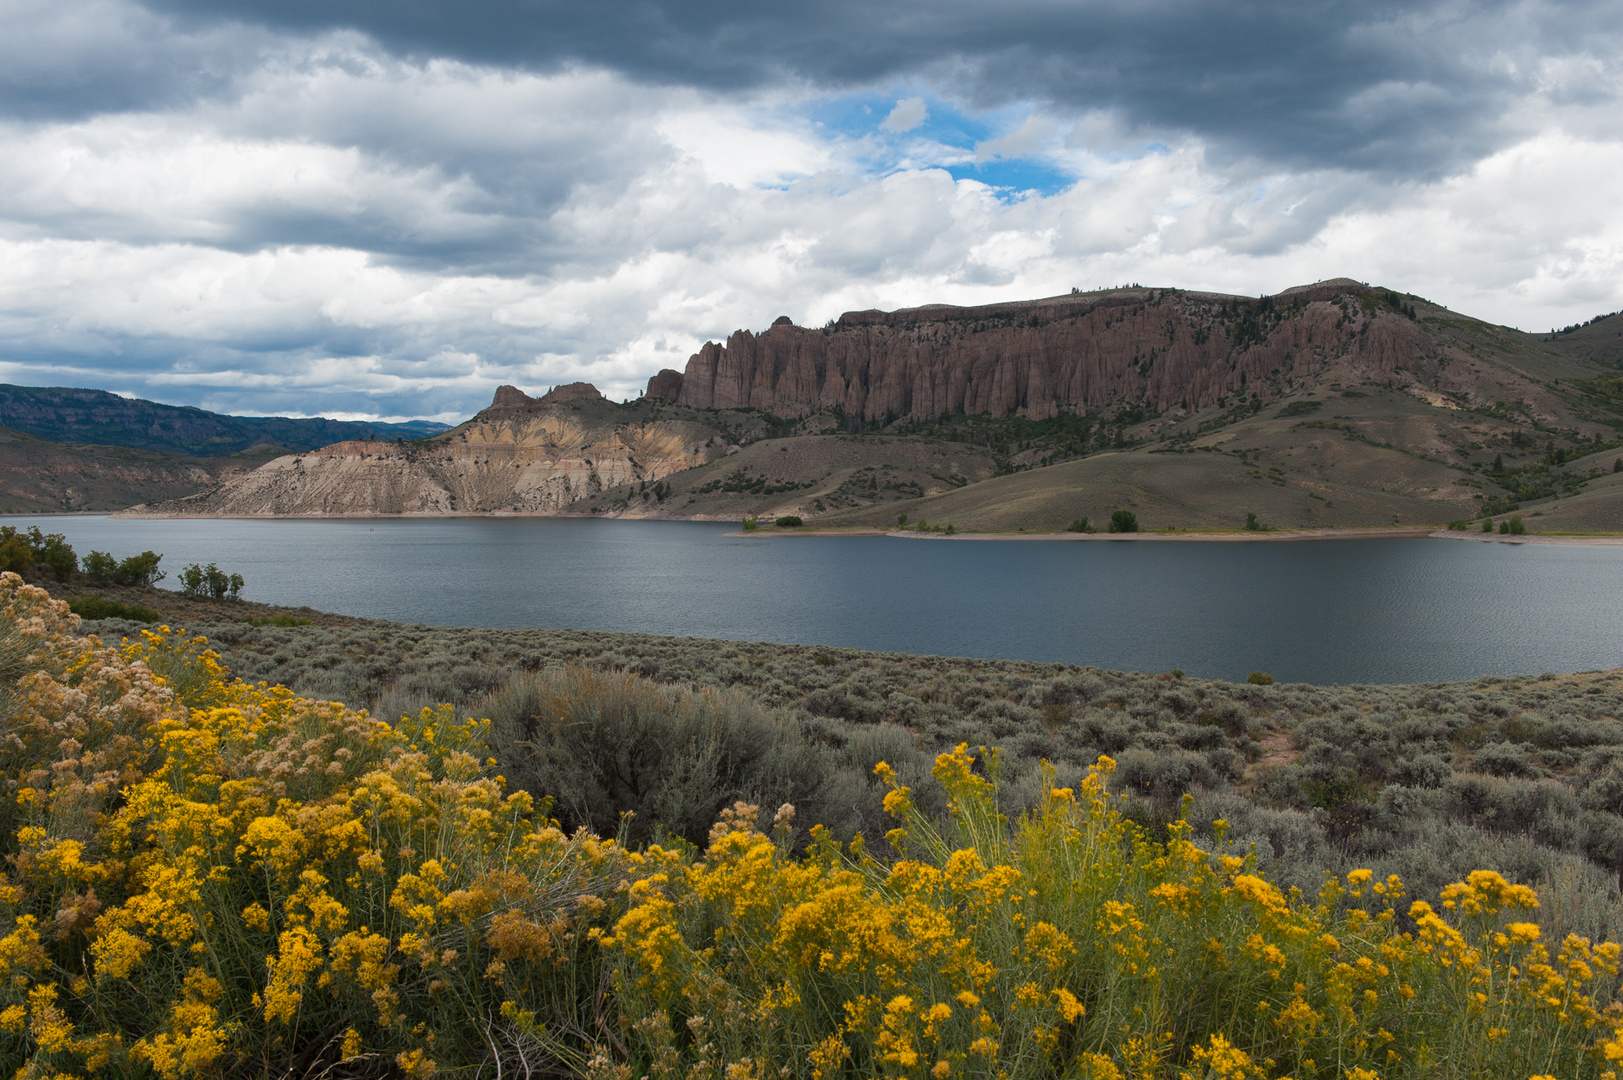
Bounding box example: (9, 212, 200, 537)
(0, 0, 1623, 419)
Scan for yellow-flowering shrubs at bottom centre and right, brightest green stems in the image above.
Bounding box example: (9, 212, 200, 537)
(601, 745, 1623, 1080)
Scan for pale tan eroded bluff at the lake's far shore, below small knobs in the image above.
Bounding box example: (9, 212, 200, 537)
(123, 383, 727, 518)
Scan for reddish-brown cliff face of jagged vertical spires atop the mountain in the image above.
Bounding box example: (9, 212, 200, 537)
(648, 279, 1448, 419)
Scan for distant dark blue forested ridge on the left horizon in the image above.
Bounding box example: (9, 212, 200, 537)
(0, 383, 450, 458)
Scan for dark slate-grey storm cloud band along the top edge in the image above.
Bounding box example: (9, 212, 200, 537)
(133, 0, 1623, 175)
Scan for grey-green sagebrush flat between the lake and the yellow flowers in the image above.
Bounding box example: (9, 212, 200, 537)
(79, 607, 1623, 940)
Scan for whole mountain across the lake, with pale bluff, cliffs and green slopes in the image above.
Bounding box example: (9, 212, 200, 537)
(129, 279, 1623, 531)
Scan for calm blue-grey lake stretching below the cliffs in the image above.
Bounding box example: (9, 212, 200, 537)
(6, 515, 1623, 684)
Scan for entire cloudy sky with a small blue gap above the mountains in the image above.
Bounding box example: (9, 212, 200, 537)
(0, 0, 1623, 422)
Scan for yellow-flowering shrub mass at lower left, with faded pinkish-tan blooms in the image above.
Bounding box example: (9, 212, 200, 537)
(0, 575, 639, 1080)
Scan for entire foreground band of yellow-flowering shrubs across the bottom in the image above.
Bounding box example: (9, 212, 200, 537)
(9, 575, 1623, 1080)
